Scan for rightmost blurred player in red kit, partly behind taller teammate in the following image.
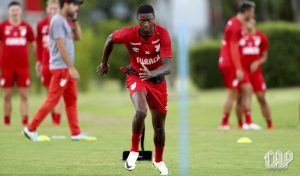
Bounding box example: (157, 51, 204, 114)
(236, 18, 273, 129)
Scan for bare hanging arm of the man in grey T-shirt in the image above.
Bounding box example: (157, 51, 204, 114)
(55, 38, 80, 80)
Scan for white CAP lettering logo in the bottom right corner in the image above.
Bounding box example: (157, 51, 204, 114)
(264, 150, 294, 170)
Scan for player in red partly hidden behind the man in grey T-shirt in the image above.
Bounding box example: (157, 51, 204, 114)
(36, 0, 63, 125)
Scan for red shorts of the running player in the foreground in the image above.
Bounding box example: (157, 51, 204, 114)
(126, 75, 168, 113)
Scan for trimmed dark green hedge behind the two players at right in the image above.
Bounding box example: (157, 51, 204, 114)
(190, 22, 300, 89)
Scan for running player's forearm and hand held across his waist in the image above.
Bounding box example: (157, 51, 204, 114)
(139, 58, 172, 80)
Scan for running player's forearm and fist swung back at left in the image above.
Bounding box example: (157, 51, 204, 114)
(97, 34, 114, 76)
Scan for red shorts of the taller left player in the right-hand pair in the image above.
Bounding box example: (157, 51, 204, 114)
(219, 65, 250, 89)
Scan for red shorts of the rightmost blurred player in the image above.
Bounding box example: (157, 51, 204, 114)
(250, 70, 267, 93)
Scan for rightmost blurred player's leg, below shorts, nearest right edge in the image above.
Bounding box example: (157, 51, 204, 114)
(256, 92, 273, 129)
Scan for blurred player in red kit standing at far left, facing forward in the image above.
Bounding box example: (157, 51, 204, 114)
(0, 1, 35, 125)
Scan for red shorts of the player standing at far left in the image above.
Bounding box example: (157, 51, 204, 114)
(0, 68, 31, 88)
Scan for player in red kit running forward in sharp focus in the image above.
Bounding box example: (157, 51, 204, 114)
(97, 4, 172, 175)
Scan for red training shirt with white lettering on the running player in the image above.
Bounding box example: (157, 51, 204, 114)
(112, 24, 172, 73)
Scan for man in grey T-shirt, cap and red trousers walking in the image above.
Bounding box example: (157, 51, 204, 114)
(23, 0, 96, 141)
